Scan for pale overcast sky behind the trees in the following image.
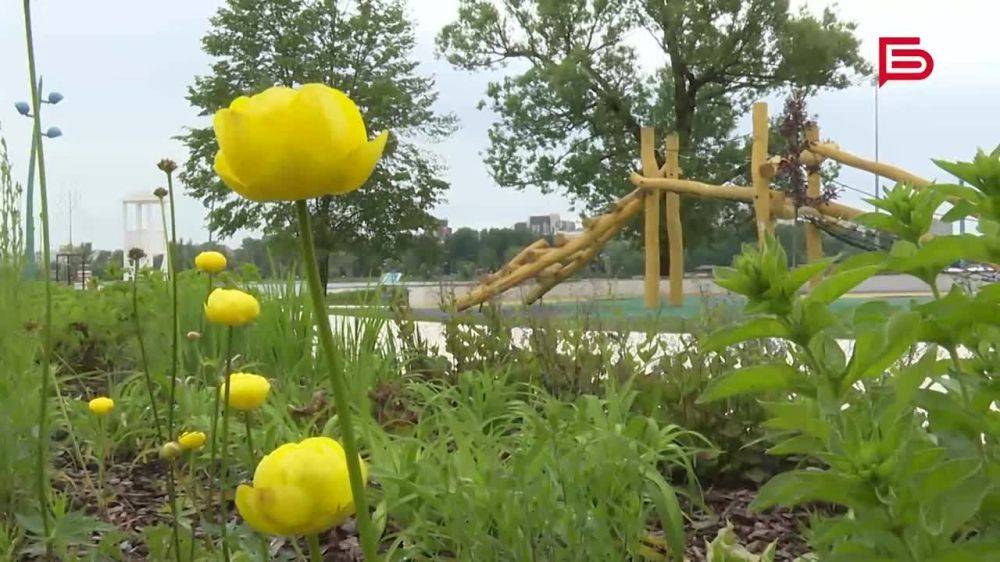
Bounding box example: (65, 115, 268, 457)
(0, 0, 1000, 249)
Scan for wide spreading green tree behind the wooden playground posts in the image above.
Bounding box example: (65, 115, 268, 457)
(438, 0, 869, 249)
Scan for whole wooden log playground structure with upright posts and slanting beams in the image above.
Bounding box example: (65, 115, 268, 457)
(455, 102, 931, 311)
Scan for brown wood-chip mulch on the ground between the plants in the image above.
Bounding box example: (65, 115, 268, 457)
(53, 449, 809, 562)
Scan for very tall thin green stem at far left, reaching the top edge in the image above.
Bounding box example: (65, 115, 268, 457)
(23, 0, 52, 559)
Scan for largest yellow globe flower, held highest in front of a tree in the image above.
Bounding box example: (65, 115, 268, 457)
(213, 84, 389, 201)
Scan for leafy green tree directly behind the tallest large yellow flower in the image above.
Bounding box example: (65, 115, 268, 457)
(181, 0, 454, 281)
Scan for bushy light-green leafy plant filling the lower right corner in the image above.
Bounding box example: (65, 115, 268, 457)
(702, 147, 1000, 561)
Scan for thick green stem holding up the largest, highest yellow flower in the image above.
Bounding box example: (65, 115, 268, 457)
(295, 200, 379, 562)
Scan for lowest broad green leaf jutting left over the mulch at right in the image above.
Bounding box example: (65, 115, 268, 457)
(750, 470, 877, 511)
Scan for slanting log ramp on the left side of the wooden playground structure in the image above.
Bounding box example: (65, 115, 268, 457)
(455, 188, 649, 311)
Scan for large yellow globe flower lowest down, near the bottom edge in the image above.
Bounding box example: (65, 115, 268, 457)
(236, 437, 368, 536)
